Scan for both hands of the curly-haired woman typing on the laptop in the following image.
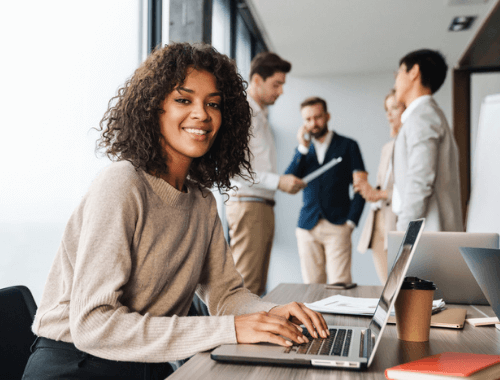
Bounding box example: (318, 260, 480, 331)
(234, 302, 329, 346)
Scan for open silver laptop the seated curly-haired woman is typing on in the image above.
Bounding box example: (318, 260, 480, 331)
(211, 219, 424, 369)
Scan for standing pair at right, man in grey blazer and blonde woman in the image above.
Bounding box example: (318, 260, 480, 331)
(355, 49, 463, 282)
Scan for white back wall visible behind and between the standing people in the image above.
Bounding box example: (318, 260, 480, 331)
(268, 70, 451, 290)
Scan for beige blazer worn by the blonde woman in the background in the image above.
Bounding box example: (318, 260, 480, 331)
(358, 140, 396, 253)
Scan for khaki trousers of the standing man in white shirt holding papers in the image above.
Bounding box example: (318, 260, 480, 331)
(226, 201, 274, 296)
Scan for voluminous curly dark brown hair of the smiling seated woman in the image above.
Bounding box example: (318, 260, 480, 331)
(96, 43, 253, 189)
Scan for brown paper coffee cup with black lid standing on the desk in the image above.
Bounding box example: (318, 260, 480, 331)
(395, 277, 436, 342)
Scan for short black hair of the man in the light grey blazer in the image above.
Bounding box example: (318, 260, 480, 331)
(399, 49, 448, 94)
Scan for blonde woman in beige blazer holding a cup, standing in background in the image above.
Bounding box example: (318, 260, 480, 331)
(355, 90, 405, 284)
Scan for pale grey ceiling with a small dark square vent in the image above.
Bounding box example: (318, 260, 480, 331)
(247, 0, 500, 76)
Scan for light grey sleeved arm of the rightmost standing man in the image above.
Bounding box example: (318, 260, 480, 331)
(397, 117, 440, 231)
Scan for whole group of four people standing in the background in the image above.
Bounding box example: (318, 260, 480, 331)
(227, 49, 463, 295)
